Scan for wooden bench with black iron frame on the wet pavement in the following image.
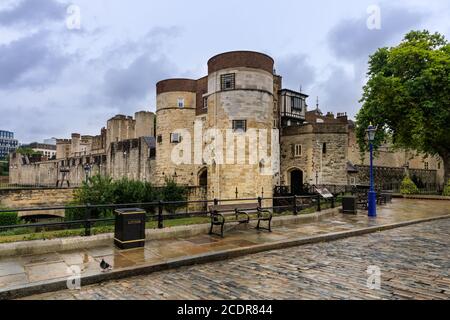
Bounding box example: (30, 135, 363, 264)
(209, 203, 273, 238)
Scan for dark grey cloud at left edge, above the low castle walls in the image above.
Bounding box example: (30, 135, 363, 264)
(0, 32, 69, 88)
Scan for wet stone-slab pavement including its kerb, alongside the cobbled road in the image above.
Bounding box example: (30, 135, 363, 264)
(0, 199, 450, 298)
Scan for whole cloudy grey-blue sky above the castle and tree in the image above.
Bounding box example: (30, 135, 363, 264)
(0, 0, 450, 142)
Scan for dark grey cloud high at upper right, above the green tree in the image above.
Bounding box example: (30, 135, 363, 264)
(327, 5, 428, 61)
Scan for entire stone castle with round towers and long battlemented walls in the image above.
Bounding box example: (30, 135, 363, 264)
(10, 51, 443, 199)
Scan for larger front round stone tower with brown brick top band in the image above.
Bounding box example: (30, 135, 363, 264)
(205, 51, 278, 205)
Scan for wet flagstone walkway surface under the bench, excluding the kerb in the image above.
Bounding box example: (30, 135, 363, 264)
(0, 199, 450, 296)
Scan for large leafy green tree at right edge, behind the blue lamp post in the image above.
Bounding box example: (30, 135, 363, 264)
(356, 30, 450, 181)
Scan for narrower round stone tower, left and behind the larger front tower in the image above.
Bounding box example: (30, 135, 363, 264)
(155, 79, 197, 185)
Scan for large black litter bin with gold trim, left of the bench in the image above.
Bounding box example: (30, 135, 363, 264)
(114, 208, 145, 249)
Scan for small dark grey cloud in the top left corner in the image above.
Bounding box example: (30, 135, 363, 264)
(0, 0, 67, 26)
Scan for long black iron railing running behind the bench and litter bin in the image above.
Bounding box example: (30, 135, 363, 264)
(0, 195, 339, 236)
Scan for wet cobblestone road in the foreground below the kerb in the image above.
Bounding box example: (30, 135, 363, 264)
(28, 219, 450, 300)
